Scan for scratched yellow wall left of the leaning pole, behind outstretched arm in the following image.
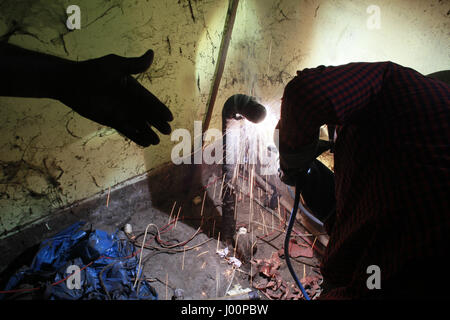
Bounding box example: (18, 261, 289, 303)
(0, 0, 226, 237)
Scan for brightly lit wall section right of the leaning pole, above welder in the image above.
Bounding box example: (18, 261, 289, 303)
(206, 0, 450, 127)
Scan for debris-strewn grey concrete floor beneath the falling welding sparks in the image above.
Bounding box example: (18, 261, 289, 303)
(0, 165, 323, 300)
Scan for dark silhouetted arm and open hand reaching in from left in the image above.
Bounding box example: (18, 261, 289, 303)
(0, 43, 173, 147)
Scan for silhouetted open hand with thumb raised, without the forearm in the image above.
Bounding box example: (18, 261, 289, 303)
(58, 50, 173, 147)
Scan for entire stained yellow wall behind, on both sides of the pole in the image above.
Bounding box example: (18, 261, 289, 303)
(0, 0, 450, 237)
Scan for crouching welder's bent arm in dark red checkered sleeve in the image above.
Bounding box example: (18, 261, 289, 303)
(277, 62, 389, 184)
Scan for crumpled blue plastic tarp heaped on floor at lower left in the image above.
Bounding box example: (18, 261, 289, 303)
(0, 222, 158, 300)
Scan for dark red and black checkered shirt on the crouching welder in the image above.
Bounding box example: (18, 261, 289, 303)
(278, 62, 450, 298)
